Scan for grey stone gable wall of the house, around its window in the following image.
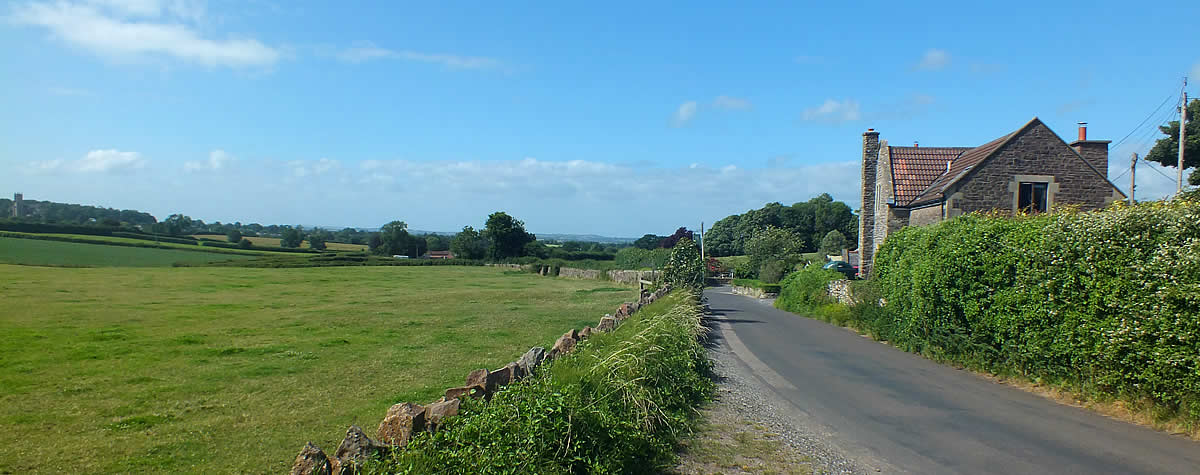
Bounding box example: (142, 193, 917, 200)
(946, 124, 1124, 214)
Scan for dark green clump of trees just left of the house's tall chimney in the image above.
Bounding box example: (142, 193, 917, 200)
(704, 194, 858, 255)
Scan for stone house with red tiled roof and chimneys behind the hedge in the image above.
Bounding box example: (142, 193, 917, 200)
(858, 118, 1124, 277)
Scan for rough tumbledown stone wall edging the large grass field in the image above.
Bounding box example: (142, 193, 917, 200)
(285, 284, 671, 475)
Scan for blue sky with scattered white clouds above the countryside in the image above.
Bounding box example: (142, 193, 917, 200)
(0, 0, 1200, 236)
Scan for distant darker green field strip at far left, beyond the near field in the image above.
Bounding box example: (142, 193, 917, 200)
(0, 238, 253, 267)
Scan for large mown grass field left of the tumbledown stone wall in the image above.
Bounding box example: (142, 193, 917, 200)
(0, 265, 635, 473)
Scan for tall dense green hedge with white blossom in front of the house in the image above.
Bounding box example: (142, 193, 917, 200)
(868, 200, 1200, 421)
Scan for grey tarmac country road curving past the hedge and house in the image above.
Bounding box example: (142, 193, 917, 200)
(704, 287, 1200, 474)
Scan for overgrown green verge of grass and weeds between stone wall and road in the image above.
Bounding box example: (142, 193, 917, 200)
(367, 292, 713, 474)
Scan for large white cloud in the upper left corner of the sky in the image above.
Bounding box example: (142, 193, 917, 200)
(11, 0, 281, 67)
